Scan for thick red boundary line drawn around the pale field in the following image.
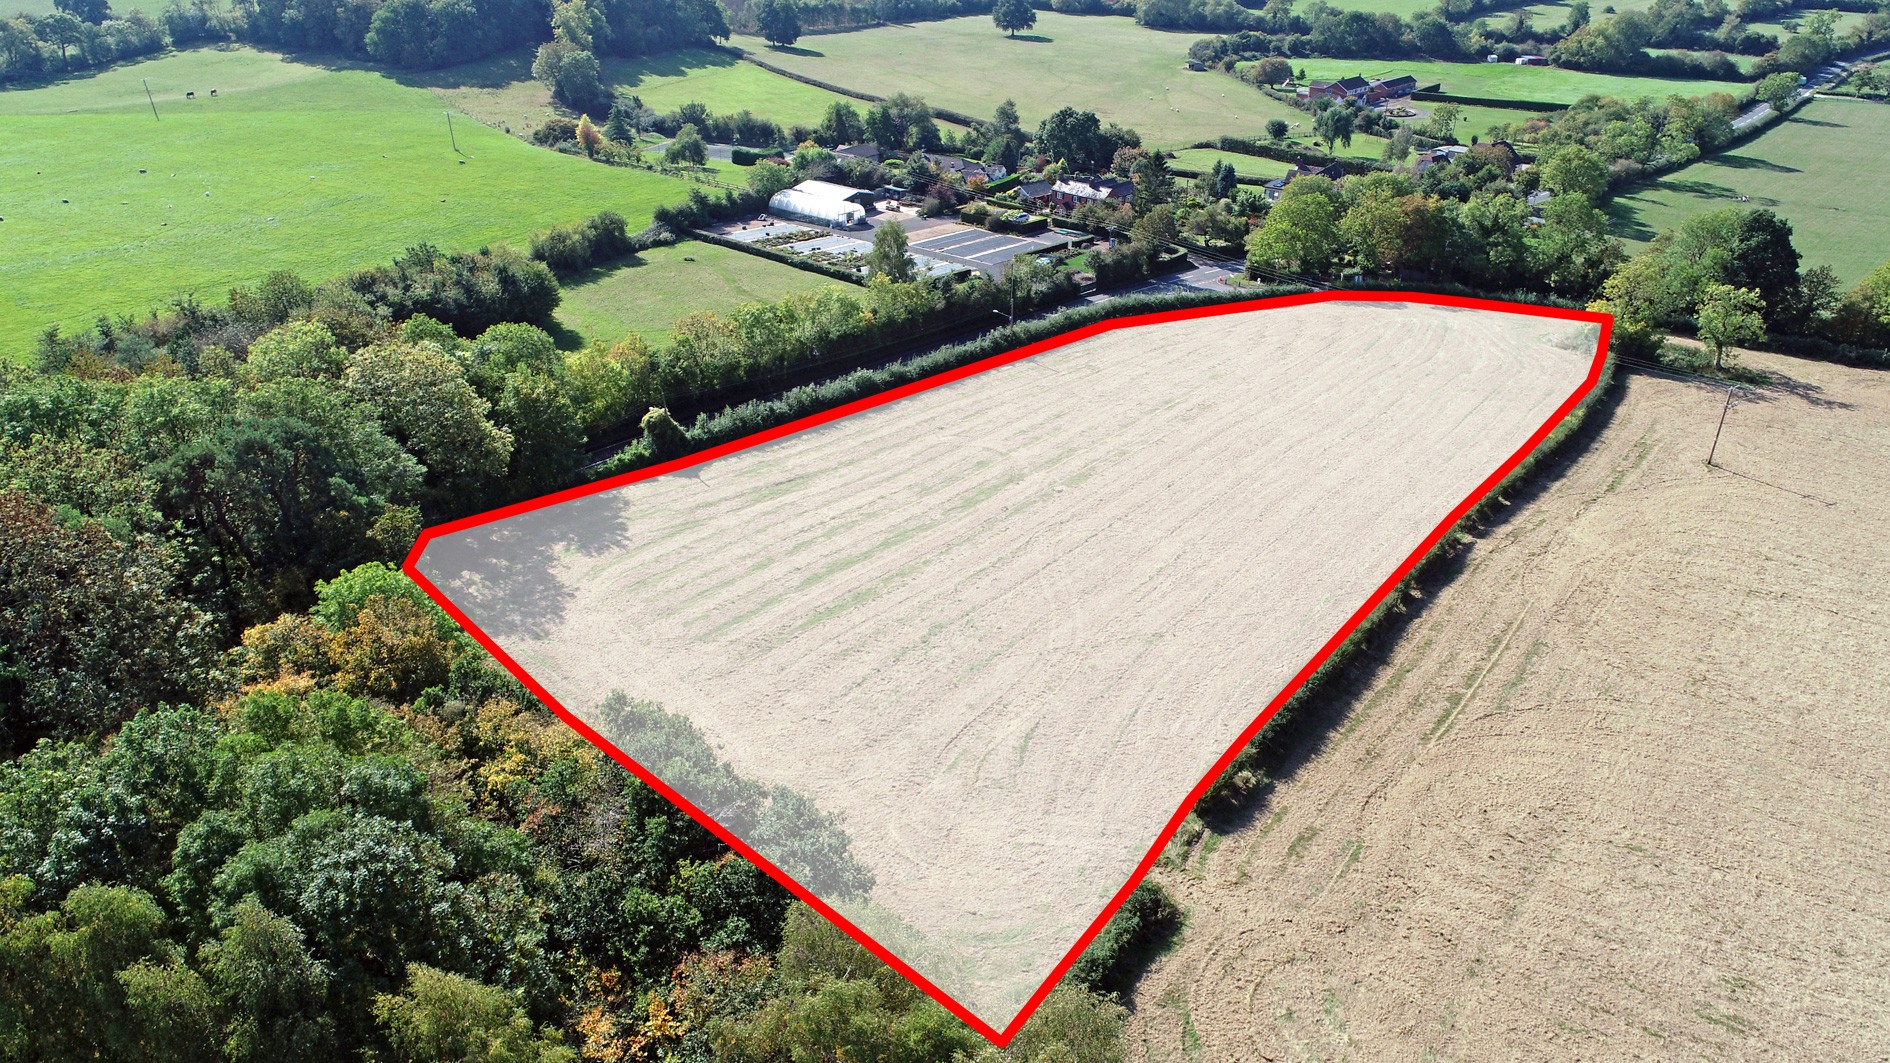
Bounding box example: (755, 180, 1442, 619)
(401, 291, 1614, 1048)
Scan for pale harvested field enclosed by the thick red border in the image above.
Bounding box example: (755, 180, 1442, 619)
(406, 297, 1599, 1027)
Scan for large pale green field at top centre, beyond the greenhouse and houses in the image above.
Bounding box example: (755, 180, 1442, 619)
(737, 11, 1380, 157)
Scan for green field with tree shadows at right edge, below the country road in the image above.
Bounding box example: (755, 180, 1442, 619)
(1608, 100, 1890, 288)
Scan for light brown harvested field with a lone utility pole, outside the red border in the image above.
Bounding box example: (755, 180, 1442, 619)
(1132, 354, 1890, 1061)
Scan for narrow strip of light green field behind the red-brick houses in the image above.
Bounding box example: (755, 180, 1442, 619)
(1293, 59, 1752, 104)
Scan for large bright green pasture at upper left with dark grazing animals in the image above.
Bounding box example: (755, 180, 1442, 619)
(0, 47, 688, 356)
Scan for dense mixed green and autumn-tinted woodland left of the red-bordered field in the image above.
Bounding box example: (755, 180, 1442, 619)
(0, 218, 1202, 1061)
